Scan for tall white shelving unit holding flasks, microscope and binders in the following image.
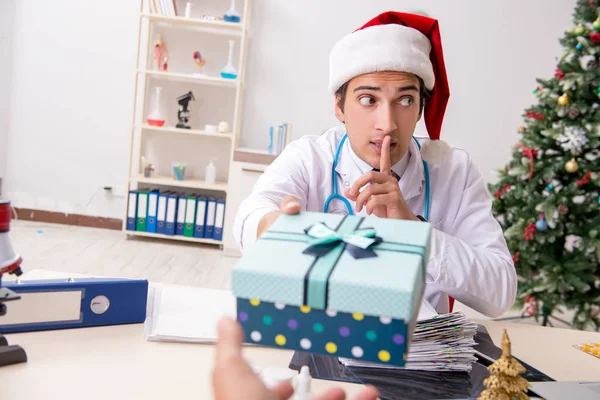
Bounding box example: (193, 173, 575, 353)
(123, 0, 251, 247)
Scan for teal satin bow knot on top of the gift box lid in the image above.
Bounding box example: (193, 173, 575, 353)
(303, 222, 383, 259)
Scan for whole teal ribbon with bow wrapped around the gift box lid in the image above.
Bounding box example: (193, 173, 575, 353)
(260, 216, 426, 310)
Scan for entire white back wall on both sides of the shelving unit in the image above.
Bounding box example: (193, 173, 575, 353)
(0, 0, 575, 218)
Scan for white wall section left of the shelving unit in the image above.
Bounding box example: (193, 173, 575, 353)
(6, 0, 138, 217)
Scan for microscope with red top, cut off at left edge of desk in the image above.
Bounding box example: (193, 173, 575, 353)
(0, 199, 27, 366)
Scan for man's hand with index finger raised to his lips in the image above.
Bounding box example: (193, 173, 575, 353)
(344, 136, 419, 221)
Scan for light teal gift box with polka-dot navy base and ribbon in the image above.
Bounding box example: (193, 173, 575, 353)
(232, 212, 431, 367)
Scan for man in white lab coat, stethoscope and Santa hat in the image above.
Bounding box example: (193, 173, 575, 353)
(234, 12, 517, 317)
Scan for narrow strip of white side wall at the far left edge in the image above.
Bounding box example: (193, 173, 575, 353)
(0, 0, 16, 196)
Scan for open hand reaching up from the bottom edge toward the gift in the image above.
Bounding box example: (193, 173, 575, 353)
(212, 318, 379, 400)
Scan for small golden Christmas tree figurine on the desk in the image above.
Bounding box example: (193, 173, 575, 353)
(478, 329, 529, 400)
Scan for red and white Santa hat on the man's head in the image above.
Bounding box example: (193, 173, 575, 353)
(329, 11, 450, 162)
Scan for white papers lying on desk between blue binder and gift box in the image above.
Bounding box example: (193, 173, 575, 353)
(144, 287, 236, 343)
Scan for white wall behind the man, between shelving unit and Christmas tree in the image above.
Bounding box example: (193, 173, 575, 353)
(242, 0, 575, 181)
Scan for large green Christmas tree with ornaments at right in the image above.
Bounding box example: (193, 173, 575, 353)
(489, 0, 600, 330)
